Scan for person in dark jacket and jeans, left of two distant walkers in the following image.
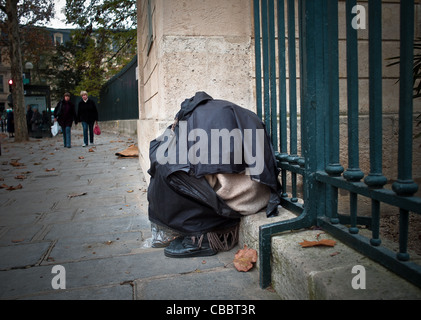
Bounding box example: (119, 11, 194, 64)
(54, 92, 77, 148)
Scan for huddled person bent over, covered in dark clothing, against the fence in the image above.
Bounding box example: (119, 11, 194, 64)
(148, 92, 280, 258)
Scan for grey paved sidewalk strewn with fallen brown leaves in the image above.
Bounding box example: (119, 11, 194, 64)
(0, 126, 279, 305)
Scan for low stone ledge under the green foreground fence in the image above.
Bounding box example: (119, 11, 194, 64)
(239, 208, 421, 300)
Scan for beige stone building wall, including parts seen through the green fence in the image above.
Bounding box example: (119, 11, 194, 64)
(137, 0, 421, 192)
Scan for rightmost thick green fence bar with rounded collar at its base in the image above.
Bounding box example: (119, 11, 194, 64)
(392, 0, 418, 196)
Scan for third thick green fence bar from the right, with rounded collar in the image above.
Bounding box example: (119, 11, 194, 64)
(344, 0, 364, 181)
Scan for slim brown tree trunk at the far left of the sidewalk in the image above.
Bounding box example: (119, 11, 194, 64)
(6, 0, 28, 142)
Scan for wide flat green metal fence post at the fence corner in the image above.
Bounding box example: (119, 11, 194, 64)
(301, 0, 329, 216)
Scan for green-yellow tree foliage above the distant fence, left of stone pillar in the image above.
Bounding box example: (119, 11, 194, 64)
(61, 0, 137, 96)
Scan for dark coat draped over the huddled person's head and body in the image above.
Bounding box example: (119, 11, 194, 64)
(148, 92, 281, 234)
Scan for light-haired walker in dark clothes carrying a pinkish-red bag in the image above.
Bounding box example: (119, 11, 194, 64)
(77, 91, 98, 147)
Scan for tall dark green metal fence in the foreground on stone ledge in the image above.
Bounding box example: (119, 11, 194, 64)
(254, 0, 421, 288)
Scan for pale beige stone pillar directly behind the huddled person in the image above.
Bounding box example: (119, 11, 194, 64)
(137, 0, 255, 181)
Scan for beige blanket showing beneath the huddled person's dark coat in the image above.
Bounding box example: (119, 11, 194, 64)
(206, 173, 270, 215)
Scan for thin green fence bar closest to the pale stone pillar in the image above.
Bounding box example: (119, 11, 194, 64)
(253, 0, 262, 119)
